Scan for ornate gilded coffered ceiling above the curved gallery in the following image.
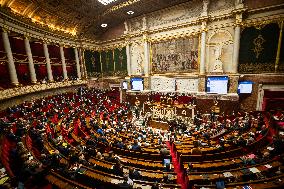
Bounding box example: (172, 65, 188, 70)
(0, 0, 190, 39)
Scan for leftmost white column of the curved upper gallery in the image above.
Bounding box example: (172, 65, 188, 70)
(2, 31, 19, 85)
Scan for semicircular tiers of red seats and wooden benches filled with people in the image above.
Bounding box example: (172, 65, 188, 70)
(1, 89, 283, 188)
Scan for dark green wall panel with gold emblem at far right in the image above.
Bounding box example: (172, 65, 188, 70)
(239, 23, 284, 73)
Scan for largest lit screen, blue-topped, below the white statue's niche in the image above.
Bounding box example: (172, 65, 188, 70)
(206, 76, 229, 94)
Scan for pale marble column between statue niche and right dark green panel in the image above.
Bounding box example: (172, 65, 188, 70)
(232, 25, 241, 73)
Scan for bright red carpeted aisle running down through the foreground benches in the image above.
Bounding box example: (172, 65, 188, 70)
(167, 142, 187, 189)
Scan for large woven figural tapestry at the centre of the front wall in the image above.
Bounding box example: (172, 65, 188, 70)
(151, 37, 199, 73)
